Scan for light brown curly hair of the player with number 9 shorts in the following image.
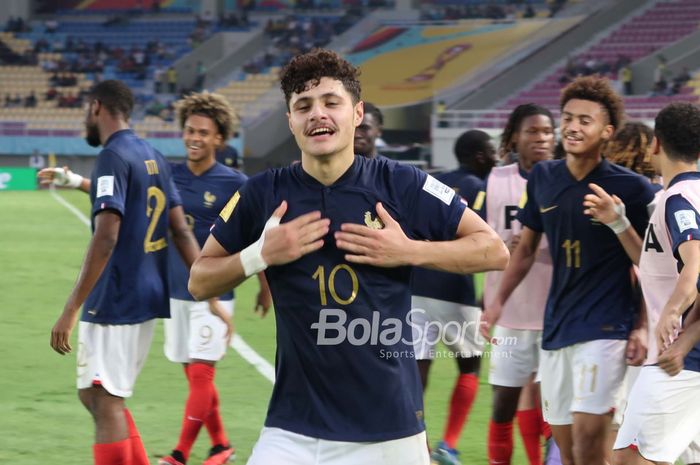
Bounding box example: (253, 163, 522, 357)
(175, 91, 238, 141)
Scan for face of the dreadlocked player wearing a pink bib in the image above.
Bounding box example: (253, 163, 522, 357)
(513, 115, 554, 171)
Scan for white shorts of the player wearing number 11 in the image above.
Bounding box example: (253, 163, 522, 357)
(539, 339, 627, 425)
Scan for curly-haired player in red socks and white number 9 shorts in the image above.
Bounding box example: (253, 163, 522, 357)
(158, 92, 258, 465)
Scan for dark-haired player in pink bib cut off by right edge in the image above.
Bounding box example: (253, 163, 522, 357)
(614, 103, 700, 464)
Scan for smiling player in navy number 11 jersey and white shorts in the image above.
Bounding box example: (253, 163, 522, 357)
(490, 77, 654, 465)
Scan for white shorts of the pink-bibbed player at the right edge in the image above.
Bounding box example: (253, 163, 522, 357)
(613, 366, 700, 463)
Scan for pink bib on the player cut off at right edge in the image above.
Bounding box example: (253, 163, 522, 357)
(639, 181, 700, 365)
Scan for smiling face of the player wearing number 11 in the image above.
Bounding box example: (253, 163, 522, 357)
(561, 99, 615, 157)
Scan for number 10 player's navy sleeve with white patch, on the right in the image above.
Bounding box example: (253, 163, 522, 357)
(394, 166, 467, 241)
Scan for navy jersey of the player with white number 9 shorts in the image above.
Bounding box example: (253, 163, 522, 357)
(169, 163, 248, 301)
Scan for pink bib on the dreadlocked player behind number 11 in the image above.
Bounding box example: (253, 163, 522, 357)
(484, 163, 552, 330)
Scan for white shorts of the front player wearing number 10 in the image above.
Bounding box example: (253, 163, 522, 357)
(247, 427, 430, 465)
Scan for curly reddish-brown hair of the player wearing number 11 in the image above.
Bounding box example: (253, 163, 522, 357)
(559, 76, 625, 130)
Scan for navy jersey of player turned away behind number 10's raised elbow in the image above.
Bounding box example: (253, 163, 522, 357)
(411, 168, 484, 306)
